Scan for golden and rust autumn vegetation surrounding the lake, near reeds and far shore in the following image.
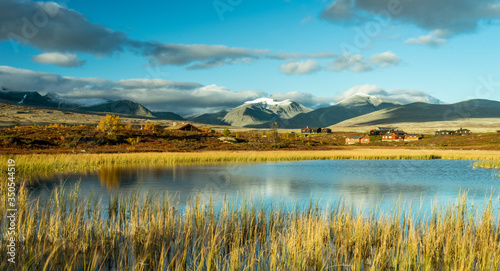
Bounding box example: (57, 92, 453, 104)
(0, 116, 500, 270)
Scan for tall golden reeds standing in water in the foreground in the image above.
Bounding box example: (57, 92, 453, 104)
(0, 184, 500, 270)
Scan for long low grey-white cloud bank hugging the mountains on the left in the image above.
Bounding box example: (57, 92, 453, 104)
(0, 66, 267, 115)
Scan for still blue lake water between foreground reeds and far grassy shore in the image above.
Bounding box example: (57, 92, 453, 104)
(31, 160, 500, 213)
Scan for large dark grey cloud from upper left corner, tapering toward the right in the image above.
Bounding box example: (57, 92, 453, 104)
(0, 0, 335, 69)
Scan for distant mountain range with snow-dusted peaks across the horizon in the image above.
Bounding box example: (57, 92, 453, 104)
(0, 90, 500, 129)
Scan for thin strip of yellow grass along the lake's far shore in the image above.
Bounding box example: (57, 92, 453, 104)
(0, 149, 500, 182)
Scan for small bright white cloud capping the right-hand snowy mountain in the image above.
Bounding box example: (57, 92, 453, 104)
(334, 84, 442, 104)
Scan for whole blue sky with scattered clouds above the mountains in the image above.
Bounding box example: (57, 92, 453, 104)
(0, 0, 500, 115)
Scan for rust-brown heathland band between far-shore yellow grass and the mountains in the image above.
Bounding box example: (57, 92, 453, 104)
(0, 120, 500, 155)
